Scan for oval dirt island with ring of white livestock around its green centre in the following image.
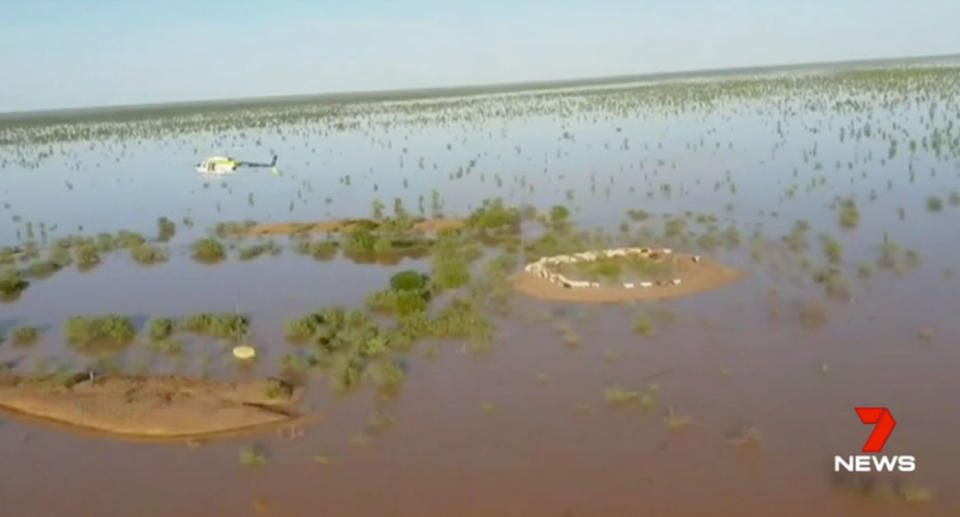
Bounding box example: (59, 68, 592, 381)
(513, 248, 743, 303)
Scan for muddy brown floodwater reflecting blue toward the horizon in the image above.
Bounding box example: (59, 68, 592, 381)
(0, 59, 960, 517)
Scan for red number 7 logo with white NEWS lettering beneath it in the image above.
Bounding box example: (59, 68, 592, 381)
(833, 407, 917, 472)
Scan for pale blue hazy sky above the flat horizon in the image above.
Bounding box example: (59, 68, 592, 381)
(0, 0, 960, 112)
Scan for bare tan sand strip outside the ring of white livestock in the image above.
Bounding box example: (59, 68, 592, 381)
(512, 253, 743, 303)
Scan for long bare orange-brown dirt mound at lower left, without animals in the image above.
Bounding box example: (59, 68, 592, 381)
(0, 374, 301, 438)
